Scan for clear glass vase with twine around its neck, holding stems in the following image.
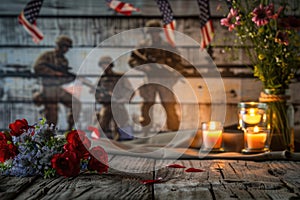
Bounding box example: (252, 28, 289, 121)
(259, 89, 295, 152)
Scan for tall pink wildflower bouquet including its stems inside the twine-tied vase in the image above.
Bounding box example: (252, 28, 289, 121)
(221, 0, 300, 150)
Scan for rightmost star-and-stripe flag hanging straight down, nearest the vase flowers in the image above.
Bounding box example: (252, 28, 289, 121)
(197, 0, 214, 49)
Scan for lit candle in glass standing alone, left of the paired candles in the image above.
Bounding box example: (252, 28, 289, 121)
(202, 121, 223, 149)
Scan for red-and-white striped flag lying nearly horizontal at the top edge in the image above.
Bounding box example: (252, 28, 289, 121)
(106, 0, 140, 16)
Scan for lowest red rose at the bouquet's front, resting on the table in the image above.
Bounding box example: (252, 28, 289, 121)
(51, 151, 80, 177)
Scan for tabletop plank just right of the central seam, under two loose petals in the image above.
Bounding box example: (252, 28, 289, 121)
(154, 160, 214, 199)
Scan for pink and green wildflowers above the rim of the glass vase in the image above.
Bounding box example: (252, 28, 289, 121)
(220, 0, 300, 89)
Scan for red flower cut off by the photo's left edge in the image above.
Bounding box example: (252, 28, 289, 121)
(0, 132, 18, 163)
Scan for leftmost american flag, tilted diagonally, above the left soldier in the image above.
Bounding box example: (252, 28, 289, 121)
(18, 0, 44, 43)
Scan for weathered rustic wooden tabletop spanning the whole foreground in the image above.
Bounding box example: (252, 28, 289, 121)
(0, 156, 300, 200)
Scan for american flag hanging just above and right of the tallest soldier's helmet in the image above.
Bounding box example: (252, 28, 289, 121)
(156, 0, 176, 46)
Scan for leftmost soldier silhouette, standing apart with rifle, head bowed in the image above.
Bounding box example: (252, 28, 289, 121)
(34, 35, 81, 130)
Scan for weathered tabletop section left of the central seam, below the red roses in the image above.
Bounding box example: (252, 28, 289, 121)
(0, 156, 154, 200)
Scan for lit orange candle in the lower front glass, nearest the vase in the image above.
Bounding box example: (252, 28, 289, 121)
(245, 126, 267, 149)
